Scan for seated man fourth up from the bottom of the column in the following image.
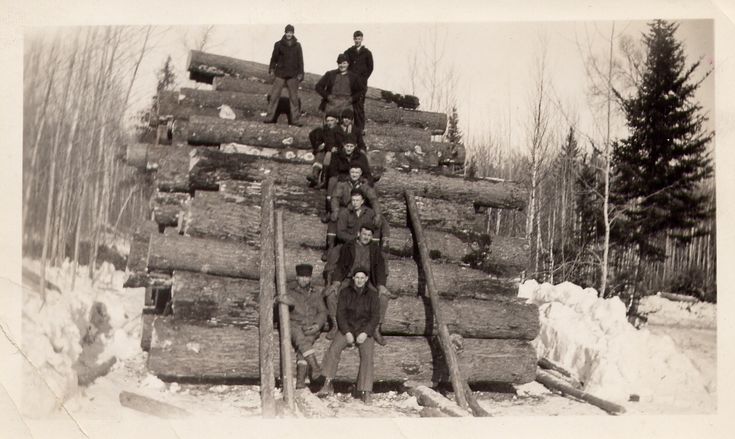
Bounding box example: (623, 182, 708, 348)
(322, 164, 382, 260)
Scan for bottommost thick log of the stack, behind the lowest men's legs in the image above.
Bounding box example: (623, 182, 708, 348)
(148, 317, 536, 384)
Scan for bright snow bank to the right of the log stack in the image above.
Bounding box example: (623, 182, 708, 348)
(518, 280, 714, 410)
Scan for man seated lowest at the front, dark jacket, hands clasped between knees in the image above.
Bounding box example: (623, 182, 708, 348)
(317, 266, 380, 404)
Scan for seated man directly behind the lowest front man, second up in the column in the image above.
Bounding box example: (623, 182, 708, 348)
(324, 223, 391, 345)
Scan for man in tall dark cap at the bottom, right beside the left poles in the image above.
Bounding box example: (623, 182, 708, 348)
(288, 264, 327, 389)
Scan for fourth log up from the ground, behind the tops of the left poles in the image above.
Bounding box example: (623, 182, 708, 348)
(181, 192, 475, 261)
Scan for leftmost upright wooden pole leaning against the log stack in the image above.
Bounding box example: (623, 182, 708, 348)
(258, 177, 276, 418)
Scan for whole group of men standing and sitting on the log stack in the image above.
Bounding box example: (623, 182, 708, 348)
(265, 25, 391, 404)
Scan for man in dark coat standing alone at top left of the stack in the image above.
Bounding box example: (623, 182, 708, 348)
(265, 24, 304, 126)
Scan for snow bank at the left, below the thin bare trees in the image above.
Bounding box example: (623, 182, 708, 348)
(22, 260, 143, 417)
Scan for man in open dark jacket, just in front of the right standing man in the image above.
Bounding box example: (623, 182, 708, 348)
(314, 53, 363, 117)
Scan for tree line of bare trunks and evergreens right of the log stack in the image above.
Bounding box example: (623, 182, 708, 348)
(462, 20, 716, 306)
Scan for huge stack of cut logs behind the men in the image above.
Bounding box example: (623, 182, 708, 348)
(126, 51, 539, 383)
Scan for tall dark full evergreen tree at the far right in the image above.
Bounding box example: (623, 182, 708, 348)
(613, 20, 713, 260)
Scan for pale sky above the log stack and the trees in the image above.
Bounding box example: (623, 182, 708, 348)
(89, 20, 715, 155)
